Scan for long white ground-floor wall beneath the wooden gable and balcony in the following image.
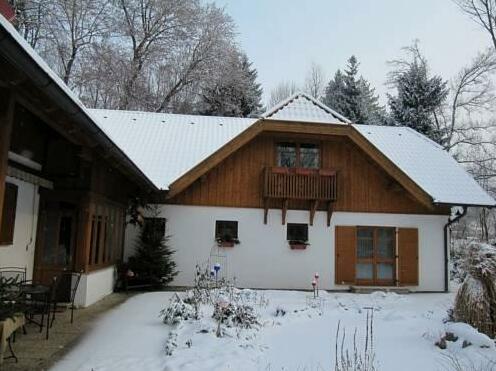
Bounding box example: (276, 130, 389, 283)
(126, 205, 448, 291)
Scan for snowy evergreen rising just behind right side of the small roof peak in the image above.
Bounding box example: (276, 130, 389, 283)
(324, 56, 384, 124)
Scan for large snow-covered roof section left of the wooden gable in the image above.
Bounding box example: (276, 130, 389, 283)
(90, 109, 257, 190)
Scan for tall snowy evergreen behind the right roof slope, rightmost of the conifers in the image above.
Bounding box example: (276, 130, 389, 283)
(388, 45, 448, 144)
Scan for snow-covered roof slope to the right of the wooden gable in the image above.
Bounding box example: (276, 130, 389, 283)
(353, 124, 496, 206)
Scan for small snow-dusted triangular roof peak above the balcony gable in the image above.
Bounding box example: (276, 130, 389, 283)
(262, 93, 350, 125)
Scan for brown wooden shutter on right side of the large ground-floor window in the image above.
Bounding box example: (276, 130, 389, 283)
(398, 228, 418, 286)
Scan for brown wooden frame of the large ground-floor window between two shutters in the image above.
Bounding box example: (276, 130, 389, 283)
(355, 226, 397, 286)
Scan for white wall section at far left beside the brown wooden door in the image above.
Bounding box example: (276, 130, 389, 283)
(0, 177, 39, 279)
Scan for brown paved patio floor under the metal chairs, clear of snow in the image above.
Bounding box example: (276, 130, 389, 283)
(0, 293, 130, 371)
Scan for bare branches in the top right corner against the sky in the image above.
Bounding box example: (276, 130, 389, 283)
(454, 0, 496, 50)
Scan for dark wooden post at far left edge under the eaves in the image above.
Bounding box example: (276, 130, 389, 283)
(0, 90, 15, 225)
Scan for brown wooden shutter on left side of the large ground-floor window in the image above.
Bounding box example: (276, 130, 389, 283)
(335, 226, 356, 285)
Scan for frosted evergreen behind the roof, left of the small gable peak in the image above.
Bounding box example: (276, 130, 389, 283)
(201, 52, 262, 117)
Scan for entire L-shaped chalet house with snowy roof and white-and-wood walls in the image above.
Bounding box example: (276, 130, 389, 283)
(0, 10, 496, 306)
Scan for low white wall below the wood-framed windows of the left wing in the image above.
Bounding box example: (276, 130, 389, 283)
(74, 266, 115, 307)
